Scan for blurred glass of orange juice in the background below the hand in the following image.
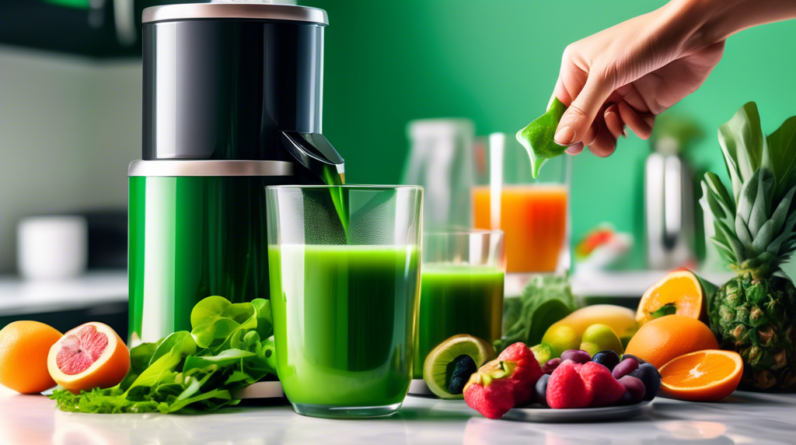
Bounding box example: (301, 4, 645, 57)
(472, 133, 570, 273)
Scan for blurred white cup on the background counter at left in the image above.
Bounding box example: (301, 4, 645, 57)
(17, 216, 88, 280)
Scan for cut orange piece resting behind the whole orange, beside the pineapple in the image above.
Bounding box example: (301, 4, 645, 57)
(636, 269, 707, 325)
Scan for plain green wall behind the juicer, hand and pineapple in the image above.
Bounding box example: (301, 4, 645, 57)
(301, 0, 796, 267)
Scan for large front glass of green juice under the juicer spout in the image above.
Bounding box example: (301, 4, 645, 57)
(266, 186, 423, 418)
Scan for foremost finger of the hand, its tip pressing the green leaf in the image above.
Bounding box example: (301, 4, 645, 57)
(555, 74, 612, 146)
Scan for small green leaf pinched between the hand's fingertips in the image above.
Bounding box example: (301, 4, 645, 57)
(517, 97, 567, 178)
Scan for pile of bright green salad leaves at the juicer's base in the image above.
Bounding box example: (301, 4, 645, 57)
(50, 296, 276, 413)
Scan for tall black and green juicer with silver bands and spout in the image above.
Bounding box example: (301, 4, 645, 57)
(128, 1, 344, 346)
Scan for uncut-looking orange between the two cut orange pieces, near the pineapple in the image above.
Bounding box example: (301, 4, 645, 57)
(625, 315, 719, 368)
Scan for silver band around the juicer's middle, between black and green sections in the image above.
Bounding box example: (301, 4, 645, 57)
(127, 160, 293, 177)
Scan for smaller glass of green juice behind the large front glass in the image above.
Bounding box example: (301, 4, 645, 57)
(410, 228, 505, 395)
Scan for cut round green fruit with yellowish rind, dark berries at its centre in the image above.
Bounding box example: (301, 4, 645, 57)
(423, 334, 496, 399)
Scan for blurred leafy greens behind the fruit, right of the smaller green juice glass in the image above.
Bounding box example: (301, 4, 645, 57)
(495, 275, 578, 350)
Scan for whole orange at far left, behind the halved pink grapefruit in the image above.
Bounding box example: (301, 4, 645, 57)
(0, 321, 61, 394)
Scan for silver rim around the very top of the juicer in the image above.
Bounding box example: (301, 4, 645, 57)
(142, 3, 329, 26)
